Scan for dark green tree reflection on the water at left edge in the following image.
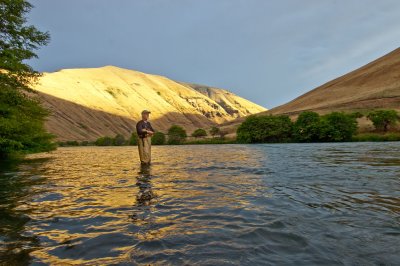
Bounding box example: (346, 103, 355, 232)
(0, 159, 47, 265)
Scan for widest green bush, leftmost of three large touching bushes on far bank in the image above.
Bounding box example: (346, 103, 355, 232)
(237, 115, 293, 143)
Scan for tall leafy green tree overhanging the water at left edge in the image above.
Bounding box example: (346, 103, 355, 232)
(0, 0, 57, 157)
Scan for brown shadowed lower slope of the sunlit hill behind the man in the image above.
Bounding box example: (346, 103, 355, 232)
(28, 92, 220, 141)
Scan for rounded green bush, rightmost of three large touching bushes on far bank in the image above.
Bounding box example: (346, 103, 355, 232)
(320, 112, 357, 141)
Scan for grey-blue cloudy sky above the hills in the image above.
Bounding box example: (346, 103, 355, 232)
(28, 0, 400, 108)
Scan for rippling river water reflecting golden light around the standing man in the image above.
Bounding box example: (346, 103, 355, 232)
(0, 143, 400, 265)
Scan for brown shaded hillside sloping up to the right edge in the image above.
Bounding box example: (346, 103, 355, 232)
(221, 48, 400, 134)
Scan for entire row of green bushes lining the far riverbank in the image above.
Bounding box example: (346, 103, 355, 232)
(58, 110, 400, 146)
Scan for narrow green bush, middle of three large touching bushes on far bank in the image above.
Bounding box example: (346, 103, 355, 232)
(293, 111, 321, 142)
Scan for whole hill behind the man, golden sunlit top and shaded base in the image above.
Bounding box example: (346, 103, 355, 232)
(29, 66, 266, 140)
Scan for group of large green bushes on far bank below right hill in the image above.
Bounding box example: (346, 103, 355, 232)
(237, 110, 400, 143)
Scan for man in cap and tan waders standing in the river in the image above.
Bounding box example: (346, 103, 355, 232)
(136, 110, 154, 164)
